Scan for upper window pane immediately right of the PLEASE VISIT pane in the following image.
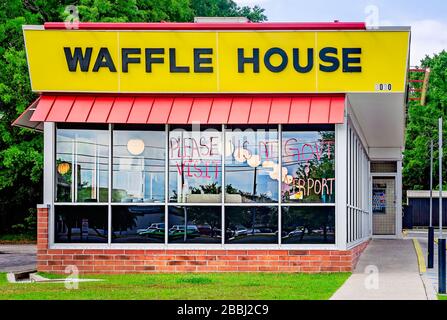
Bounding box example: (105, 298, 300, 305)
(225, 126, 280, 203)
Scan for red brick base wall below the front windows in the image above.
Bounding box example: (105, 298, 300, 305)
(37, 208, 368, 273)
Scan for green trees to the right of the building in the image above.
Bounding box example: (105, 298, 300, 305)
(403, 51, 447, 190)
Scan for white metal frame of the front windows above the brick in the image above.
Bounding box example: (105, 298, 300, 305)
(50, 123, 340, 250)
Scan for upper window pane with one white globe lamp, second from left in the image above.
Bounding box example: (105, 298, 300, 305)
(112, 126, 165, 202)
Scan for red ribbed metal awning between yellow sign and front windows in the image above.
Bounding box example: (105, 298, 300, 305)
(16, 95, 345, 127)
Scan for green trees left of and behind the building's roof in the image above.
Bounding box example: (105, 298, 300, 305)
(0, 0, 266, 232)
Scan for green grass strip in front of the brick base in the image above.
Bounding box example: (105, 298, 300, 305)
(0, 273, 350, 300)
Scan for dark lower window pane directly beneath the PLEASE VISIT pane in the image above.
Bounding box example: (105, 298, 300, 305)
(168, 206, 222, 243)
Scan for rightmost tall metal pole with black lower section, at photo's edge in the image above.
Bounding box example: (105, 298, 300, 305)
(438, 118, 446, 294)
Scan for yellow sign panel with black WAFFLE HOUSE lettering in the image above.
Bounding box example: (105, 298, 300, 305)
(24, 29, 409, 93)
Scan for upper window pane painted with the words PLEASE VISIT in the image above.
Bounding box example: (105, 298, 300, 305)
(169, 127, 222, 203)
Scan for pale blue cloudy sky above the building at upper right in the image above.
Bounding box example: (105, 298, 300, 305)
(234, 0, 447, 66)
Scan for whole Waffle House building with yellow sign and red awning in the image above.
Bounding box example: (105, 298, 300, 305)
(14, 22, 410, 273)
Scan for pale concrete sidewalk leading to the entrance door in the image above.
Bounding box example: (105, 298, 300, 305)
(331, 239, 427, 300)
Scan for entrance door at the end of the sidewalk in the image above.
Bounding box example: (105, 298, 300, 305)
(372, 177, 396, 236)
